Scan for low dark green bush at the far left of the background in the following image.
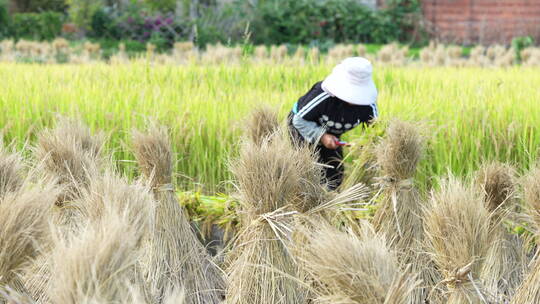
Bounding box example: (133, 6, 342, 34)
(12, 12, 64, 40)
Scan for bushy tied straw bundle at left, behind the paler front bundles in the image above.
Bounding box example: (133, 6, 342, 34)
(23, 118, 105, 303)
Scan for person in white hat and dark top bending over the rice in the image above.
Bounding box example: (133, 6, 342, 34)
(288, 57, 378, 190)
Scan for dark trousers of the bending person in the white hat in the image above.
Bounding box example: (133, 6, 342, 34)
(287, 113, 345, 190)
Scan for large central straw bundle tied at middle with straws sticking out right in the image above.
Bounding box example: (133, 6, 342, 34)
(226, 135, 320, 304)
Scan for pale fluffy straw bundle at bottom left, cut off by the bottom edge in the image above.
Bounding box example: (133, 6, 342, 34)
(47, 205, 149, 304)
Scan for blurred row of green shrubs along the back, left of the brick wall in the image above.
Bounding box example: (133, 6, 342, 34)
(0, 0, 421, 50)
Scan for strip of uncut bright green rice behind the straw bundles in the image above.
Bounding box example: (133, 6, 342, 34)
(0, 63, 540, 193)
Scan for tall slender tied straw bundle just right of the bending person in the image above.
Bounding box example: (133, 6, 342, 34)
(373, 120, 436, 303)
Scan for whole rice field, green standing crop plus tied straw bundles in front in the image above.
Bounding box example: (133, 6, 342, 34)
(0, 61, 540, 304)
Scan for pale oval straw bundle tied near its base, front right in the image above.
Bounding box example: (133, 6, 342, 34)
(424, 177, 492, 304)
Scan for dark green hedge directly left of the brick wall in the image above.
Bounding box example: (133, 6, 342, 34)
(253, 0, 420, 44)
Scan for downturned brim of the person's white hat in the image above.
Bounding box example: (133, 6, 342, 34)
(322, 66, 378, 105)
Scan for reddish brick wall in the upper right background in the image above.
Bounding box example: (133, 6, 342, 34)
(422, 0, 540, 44)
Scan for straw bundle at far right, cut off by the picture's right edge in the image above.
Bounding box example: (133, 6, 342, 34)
(511, 167, 540, 304)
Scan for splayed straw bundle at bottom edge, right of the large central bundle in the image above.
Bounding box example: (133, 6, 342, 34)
(298, 221, 419, 304)
